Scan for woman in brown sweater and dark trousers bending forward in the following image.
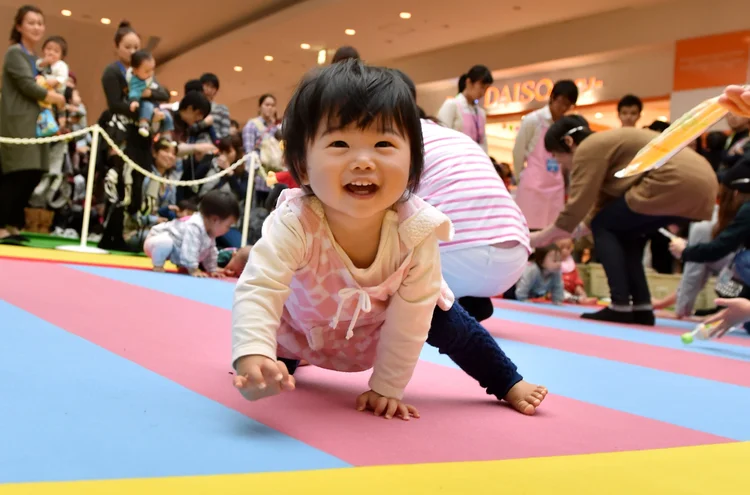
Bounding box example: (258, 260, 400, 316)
(531, 115, 718, 325)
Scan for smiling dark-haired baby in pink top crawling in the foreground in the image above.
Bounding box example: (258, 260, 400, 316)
(232, 61, 547, 420)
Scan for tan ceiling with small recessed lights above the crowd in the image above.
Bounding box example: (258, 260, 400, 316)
(0, 0, 661, 120)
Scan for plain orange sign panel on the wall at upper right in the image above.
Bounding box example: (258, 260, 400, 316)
(674, 31, 750, 91)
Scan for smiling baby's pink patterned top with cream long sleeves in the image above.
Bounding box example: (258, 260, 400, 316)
(232, 189, 453, 399)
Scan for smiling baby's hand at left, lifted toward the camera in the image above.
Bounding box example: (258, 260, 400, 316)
(234, 355, 294, 400)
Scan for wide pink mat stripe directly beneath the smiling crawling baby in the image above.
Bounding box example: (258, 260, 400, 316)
(0, 260, 727, 465)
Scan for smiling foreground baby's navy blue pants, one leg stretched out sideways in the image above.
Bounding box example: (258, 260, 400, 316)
(279, 302, 523, 399)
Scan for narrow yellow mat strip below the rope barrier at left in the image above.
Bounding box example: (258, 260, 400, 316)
(0, 245, 177, 271)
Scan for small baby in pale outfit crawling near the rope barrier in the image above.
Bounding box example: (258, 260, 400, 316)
(143, 191, 240, 277)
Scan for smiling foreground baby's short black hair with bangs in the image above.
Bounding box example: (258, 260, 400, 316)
(281, 59, 424, 193)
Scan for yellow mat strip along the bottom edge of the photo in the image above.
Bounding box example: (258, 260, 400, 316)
(0, 444, 750, 495)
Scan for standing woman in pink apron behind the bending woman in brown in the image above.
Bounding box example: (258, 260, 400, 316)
(513, 80, 578, 230)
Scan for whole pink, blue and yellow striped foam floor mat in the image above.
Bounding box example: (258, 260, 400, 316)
(0, 258, 750, 495)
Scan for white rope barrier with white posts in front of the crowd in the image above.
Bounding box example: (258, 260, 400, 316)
(0, 124, 268, 254)
